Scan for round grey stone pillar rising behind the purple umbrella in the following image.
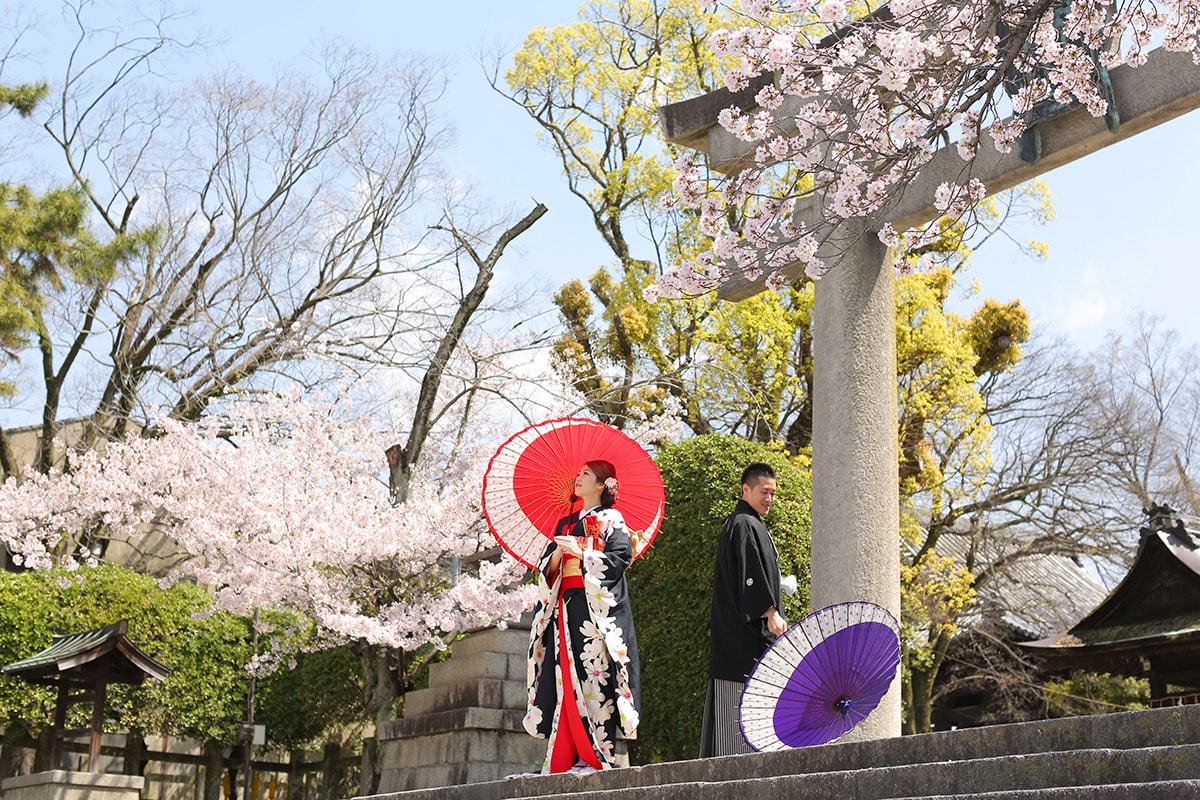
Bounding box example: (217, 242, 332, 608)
(811, 215, 900, 740)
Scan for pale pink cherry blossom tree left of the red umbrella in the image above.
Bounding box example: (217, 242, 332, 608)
(0, 392, 532, 721)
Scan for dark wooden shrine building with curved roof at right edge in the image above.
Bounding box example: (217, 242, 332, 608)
(1020, 505, 1200, 706)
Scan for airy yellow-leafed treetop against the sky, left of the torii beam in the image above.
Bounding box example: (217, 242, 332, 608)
(504, 0, 720, 241)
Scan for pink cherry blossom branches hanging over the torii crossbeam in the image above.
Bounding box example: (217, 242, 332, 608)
(647, 0, 1200, 299)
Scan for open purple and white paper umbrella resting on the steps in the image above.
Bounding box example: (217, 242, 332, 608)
(739, 602, 900, 751)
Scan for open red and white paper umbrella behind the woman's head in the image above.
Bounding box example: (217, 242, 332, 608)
(484, 417, 666, 569)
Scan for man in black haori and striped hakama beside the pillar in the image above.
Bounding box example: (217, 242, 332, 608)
(700, 462, 787, 758)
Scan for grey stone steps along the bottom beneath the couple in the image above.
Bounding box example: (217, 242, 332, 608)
(360, 705, 1200, 800)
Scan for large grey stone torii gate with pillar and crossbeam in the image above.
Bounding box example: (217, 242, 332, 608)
(659, 50, 1200, 739)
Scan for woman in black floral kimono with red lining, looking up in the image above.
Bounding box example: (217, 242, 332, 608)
(524, 461, 641, 772)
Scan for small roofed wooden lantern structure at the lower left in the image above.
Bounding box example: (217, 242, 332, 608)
(0, 619, 170, 772)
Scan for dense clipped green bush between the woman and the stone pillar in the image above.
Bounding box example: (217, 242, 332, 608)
(629, 434, 811, 763)
